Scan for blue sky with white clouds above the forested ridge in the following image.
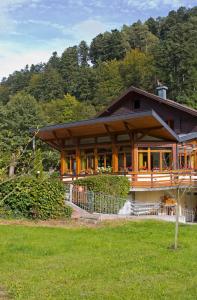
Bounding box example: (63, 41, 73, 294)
(0, 0, 197, 79)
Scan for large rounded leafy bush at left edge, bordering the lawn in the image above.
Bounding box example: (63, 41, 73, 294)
(0, 176, 72, 220)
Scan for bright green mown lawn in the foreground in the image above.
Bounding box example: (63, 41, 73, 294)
(0, 221, 197, 300)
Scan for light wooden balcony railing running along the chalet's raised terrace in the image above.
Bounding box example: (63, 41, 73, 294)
(62, 170, 197, 190)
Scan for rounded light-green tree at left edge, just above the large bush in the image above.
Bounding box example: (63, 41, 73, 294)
(0, 92, 43, 175)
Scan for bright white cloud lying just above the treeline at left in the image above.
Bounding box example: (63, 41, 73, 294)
(0, 15, 115, 79)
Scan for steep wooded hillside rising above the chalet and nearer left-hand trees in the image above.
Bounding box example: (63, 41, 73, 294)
(0, 7, 197, 107)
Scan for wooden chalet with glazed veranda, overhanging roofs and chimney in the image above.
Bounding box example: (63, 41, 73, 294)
(34, 86, 197, 216)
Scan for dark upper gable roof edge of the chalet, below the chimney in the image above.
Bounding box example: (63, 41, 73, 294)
(97, 86, 197, 118)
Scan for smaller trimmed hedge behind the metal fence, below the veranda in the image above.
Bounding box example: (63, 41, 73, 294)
(74, 174, 130, 197)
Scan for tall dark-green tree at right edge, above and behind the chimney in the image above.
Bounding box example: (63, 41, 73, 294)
(154, 16, 197, 103)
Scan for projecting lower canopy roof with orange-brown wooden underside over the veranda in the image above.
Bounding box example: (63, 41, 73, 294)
(31, 110, 179, 148)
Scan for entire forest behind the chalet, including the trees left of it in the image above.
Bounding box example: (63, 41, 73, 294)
(0, 7, 197, 175)
